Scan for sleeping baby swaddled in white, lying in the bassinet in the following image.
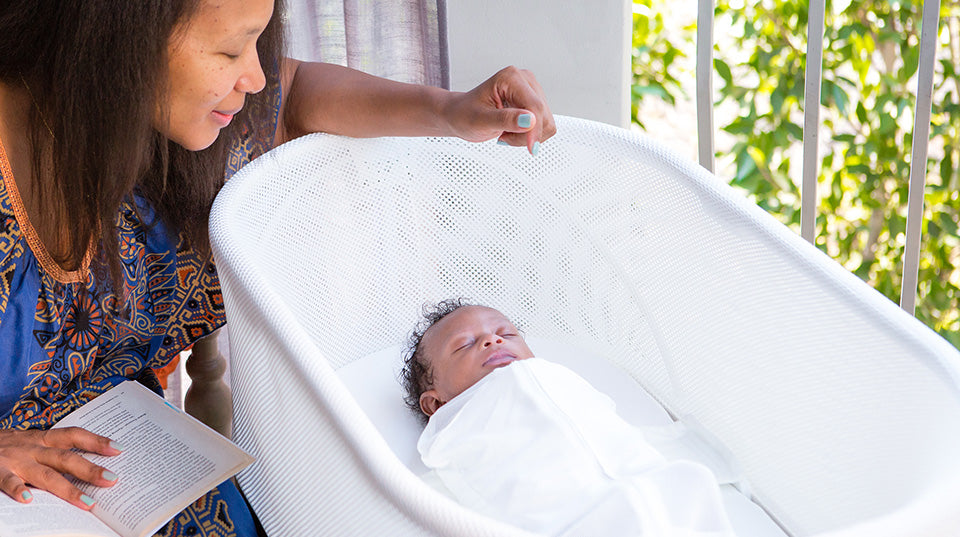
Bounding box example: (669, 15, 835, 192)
(402, 300, 734, 537)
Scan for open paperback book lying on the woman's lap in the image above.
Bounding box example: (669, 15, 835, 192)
(0, 381, 253, 537)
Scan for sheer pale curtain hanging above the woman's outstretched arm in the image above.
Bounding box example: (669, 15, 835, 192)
(284, 0, 450, 88)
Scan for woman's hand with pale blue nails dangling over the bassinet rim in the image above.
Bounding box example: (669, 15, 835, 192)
(445, 67, 557, 155)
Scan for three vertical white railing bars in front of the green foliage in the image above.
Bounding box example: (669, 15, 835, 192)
(697, 0, 940, 314)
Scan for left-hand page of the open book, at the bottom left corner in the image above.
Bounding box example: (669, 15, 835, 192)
(0, 489, 119, 537)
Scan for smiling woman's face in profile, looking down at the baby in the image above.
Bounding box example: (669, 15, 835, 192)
(154, 0, 273, 151)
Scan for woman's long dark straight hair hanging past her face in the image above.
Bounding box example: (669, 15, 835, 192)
(0, 0, 282, 291)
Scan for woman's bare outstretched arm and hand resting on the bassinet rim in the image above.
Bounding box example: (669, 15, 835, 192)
(276, 59, 556, 152)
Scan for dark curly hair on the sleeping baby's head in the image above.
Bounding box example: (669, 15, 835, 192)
(400, 298, 475, 423)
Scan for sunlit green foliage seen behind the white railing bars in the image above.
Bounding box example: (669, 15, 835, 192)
(633, 0, 960, 346)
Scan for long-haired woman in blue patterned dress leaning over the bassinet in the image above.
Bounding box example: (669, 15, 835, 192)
(0, 0, 555, 535)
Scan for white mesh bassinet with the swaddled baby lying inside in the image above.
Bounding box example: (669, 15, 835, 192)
(211, 118, 960, 537)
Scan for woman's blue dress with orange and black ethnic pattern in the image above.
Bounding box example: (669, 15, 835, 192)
(0, 80, 280, 537)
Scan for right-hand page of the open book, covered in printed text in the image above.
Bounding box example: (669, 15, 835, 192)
(56, 381, 253, 537)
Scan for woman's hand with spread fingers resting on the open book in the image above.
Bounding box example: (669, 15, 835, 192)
(0, 427, 121, 510)
